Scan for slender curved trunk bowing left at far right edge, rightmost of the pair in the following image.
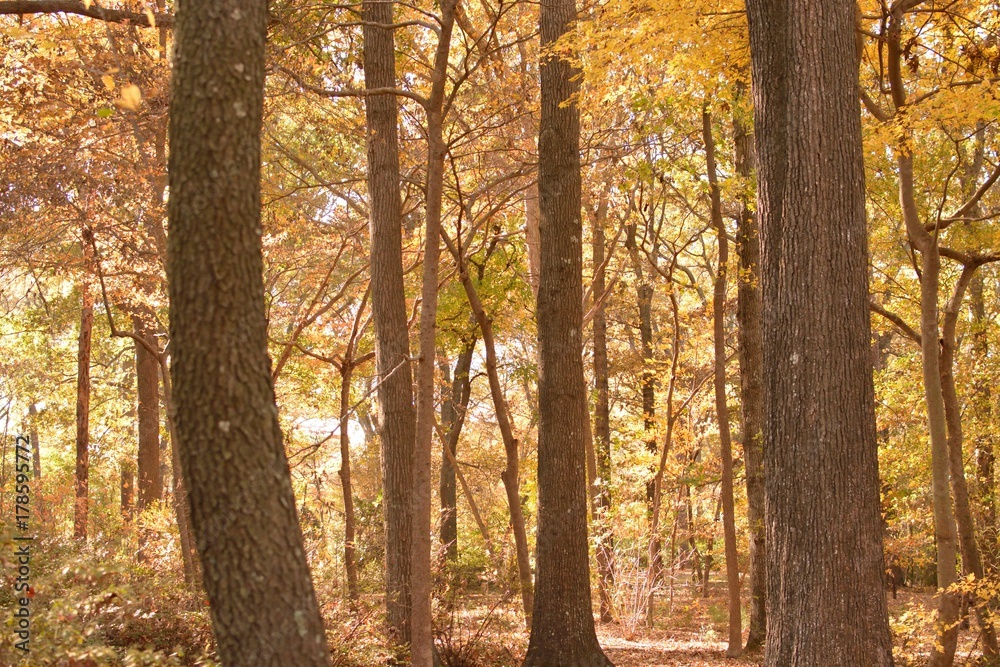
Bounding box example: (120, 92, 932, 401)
(941, 262, 997, 661)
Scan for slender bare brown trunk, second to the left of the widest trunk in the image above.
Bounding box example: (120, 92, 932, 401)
(702, 109, 743, 657)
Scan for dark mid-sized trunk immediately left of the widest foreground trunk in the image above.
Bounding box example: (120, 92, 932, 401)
(733, 111, 767, 651)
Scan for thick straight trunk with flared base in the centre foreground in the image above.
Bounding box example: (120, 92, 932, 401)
(524, 0, 611, 667)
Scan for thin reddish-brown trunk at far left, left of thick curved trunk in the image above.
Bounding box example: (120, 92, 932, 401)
(73, 245, 94, 540)
